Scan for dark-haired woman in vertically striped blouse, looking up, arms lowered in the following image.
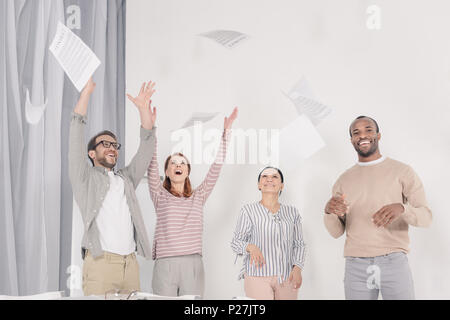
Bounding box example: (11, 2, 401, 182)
(231, 167, 305, 300)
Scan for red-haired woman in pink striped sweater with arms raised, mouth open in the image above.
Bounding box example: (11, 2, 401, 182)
(148, 108, 237, 296)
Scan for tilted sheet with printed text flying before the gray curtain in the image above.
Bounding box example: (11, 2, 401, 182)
(49, 22, 101, 91)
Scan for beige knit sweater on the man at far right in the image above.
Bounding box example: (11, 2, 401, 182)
(324, 158, 431, 257)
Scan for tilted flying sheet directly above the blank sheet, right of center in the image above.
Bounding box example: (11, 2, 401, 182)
(286, 77, 332, 125)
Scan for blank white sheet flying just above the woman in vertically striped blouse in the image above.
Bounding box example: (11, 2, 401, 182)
(279, 115, 325, 170)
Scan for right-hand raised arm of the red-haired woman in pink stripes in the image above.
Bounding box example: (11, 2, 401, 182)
(197, 107, 238, 202)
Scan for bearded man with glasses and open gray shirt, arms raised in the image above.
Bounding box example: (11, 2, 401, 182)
(69, 79, 156, 295)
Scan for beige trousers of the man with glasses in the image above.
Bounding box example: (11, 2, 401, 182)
(83, 252, 140, 296)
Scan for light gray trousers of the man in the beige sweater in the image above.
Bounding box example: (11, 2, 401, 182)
(344, 252, 415, 300)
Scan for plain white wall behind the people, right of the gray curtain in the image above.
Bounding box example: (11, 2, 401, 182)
(120, 0, 450, 299)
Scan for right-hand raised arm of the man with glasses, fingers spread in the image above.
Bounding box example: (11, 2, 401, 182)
(123, 81, 156, 188)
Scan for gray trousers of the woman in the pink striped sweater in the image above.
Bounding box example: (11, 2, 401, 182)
(152, 254, 205, 297)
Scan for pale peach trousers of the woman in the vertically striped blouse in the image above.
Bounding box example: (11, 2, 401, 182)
(244, 275, 298, 300)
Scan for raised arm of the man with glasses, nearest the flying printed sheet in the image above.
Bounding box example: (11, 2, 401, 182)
(69, 78, 95, 189)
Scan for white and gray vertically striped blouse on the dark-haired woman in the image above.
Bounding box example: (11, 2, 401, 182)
(231, 202, 306, 282)
